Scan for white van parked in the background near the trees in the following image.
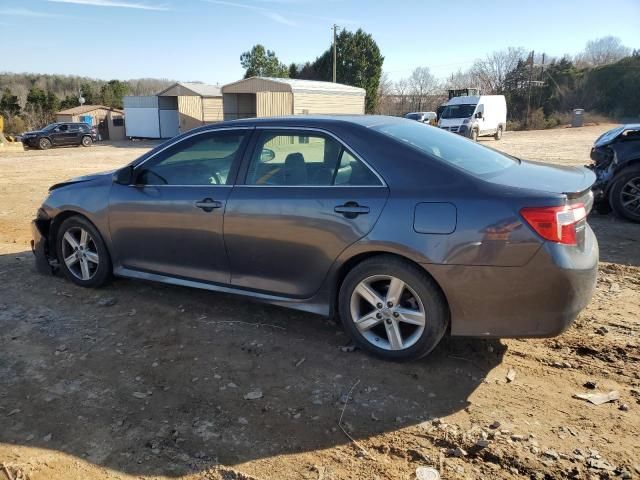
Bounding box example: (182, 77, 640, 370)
(438, 95, 507, 141)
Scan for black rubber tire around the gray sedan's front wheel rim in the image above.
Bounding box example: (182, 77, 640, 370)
(56, 216, 111, 288)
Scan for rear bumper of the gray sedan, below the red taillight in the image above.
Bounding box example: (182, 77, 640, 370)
(424, 226, 598, 338)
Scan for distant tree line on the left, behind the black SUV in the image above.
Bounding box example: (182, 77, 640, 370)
(0, 73, 172, 133)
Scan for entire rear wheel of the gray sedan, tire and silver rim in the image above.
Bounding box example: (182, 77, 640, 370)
(338, 255, 449, 360)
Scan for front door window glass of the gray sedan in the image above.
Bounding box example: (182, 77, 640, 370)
(137, 131, 245, 185)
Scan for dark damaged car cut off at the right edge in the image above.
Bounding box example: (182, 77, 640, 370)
(589, 124, 640, 222)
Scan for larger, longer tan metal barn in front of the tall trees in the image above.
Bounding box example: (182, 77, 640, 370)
(222, 77, 365, 120)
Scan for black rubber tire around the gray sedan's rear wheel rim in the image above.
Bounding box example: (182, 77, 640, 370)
(338, 255, 449, 361)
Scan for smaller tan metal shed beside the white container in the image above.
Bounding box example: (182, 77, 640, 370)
(157, 82, 223, 132)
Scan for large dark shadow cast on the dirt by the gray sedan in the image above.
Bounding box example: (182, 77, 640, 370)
(0, 252, 506, 476)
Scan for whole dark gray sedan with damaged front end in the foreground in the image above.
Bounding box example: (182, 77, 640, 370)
(33, 116, 598, 359)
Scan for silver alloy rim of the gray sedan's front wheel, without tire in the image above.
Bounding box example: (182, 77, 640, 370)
(62, 227, 100, 281)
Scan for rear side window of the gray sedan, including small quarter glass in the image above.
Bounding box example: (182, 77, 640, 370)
(246, 131, 381, 186)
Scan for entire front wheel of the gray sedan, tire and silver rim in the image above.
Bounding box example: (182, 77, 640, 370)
(56, 217, 111, 287)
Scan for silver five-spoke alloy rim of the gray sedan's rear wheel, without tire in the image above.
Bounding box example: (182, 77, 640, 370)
(350, 275, 426, 350)
